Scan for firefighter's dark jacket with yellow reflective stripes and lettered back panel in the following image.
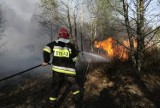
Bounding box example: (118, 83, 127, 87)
(43, 41, 78, 75)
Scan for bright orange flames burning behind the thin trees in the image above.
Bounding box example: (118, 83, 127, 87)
(94, 37, 129, 60)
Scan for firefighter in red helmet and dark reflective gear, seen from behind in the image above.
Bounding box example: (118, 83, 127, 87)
(42, 28, 80, 107)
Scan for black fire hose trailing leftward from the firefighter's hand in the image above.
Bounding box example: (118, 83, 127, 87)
(0, 64, 42, 82)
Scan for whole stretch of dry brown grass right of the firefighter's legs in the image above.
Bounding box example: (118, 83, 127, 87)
(84, 58, 160, 108)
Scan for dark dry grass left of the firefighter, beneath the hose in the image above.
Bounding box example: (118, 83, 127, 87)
(0, 72, 50, 108)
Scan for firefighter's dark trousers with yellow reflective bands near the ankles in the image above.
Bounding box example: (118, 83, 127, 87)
(51, 71, 80, 100)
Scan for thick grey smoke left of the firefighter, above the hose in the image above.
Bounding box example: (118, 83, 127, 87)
(0, 0, 47, 78)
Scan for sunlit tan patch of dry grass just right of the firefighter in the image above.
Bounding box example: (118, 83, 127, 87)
(84, 69, 114, 100)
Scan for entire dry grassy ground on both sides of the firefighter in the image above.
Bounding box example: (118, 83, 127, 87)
(0, 63, 160, 108)
